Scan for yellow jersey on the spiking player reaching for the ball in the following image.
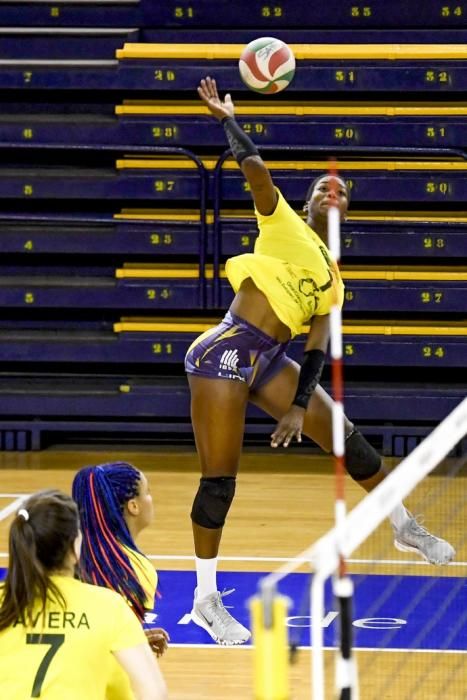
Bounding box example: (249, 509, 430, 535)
(225, 188, 344, 338)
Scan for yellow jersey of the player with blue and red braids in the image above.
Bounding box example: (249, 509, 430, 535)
(105, 547, 157, 700)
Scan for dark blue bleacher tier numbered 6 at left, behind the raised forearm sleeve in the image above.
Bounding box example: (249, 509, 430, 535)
(0, 110, 467, 153)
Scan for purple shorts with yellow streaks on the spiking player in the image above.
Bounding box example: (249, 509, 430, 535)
(185, 311, 291, 389)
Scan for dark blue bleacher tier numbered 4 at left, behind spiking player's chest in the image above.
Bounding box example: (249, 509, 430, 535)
(0, 213, 467, 263)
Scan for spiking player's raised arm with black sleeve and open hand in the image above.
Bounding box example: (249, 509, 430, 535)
(198, 77, 277, 216)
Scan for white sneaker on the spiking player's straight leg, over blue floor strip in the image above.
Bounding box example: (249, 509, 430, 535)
(191, 590, 251, 646)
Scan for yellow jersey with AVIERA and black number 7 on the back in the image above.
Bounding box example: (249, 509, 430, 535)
(0, 576, 146, 700)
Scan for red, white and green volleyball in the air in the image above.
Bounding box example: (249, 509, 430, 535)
(238, 36, 295, 95)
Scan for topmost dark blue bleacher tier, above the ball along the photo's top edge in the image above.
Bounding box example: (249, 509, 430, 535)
(0, 0, 466, 31)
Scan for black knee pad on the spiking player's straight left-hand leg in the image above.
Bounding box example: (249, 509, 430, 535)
(191, 476, 236, 530)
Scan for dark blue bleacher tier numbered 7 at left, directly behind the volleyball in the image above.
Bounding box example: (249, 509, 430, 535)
(0, 59, 467, 97)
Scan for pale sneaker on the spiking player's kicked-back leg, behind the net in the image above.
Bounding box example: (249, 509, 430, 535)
(393, 516, 456, 564)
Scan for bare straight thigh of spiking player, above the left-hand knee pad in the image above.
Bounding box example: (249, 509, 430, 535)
(188, 375, 249, 476)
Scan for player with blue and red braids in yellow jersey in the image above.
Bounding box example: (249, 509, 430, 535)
(72, 462, 169, 700)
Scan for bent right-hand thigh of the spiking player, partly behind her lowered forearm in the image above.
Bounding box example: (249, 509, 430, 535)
(250, 360, 353, 452)
